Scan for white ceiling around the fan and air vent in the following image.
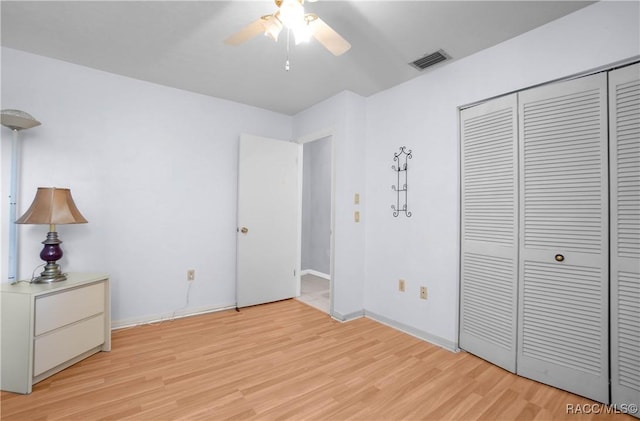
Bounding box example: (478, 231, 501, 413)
(0, 0, 593, 115)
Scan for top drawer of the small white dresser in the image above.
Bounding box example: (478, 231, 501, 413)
(34, 282, 105, 336)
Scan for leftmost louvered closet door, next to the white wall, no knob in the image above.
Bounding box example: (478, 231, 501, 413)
(459, 94, 518, 372)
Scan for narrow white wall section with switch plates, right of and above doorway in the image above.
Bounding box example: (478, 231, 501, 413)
(293, 92, 366, 320)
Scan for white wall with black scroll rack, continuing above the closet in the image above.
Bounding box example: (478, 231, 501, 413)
(364, 2, 640, 347)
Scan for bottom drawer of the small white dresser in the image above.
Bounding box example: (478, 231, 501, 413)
(33, 314, 104, 377)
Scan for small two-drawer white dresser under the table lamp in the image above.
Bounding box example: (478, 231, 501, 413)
(0, 273, 111, 393)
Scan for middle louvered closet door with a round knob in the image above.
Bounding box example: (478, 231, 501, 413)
(518, 74, 609, 403)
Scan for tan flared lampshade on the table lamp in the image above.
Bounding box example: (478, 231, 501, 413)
(16, 187, 88, 225)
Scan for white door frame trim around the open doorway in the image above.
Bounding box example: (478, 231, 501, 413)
(295, 128, 336, 316)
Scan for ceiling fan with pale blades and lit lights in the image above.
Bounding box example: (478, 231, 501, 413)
(224, 0, 351, 56)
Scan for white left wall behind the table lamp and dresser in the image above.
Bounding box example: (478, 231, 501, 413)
(1, 48, 292, 325)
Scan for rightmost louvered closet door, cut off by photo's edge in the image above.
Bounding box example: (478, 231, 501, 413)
(609, 64, 640, 406)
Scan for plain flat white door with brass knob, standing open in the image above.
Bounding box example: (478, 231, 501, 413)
(236, 135, 302, 307)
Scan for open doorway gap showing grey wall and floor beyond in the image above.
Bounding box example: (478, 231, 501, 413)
(298, 136, 333, 314)
